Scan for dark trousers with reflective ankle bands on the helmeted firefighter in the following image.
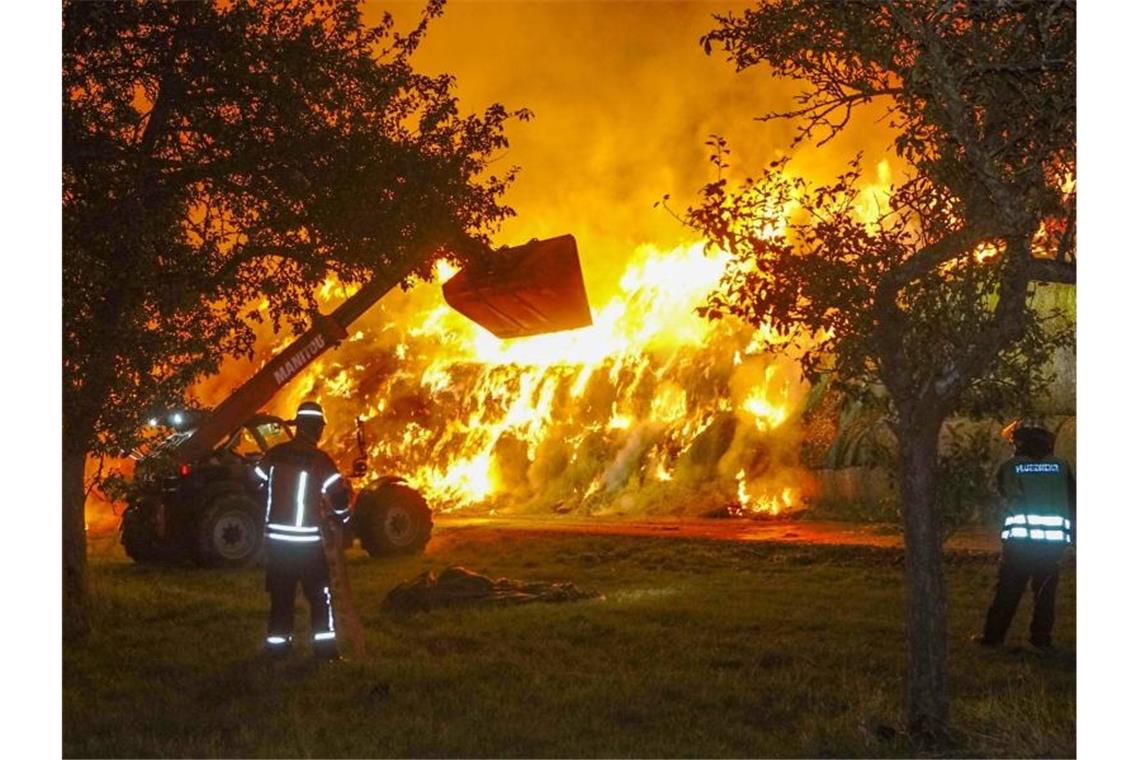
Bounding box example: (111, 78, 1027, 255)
(266, 541, 336, 656)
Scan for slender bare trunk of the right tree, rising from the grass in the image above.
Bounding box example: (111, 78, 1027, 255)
(899, 419, 950, 745)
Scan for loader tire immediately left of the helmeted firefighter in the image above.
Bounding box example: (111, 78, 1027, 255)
(194, 491, 264, 567)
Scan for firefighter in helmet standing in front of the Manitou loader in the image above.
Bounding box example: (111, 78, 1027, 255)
(254, 401, 350, 660)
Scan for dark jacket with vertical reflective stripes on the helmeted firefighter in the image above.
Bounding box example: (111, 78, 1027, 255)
(254, 436, 349, 544)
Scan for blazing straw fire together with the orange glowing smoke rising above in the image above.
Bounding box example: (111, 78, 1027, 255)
(88, 0, 912, 528)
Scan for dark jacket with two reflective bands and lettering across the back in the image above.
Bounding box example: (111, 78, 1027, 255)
(998, 456, 1076, 546)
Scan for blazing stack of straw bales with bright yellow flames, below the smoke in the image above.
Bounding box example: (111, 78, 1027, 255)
(254, 243, 809, 514)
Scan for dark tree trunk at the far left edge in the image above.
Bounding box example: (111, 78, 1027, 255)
(63, 442, 90, 640)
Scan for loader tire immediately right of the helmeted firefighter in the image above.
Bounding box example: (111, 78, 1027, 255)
(351, 481, 432, 557)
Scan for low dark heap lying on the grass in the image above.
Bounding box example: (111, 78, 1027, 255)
(381, 566, 601, 613)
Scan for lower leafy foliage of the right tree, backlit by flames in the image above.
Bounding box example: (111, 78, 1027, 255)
(689, 152, 1073, 428)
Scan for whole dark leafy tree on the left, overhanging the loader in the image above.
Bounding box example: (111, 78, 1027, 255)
(63, 0, 528, 634)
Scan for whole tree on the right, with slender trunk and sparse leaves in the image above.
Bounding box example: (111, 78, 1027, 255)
(686, 0, 1076, 741)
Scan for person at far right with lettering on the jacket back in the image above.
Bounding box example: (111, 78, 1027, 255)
(974, 418, 1076, 648)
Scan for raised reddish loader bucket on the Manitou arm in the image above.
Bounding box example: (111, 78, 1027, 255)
(443, 235, 593, 338)
